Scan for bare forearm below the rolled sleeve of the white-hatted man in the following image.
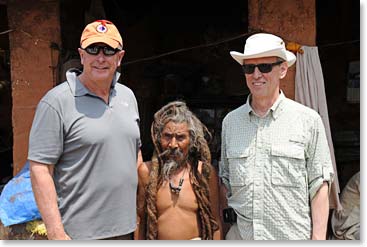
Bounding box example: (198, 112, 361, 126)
(311, 182, 329, 240)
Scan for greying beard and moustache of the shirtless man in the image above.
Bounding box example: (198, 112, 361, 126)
(162, 149, 187, 180)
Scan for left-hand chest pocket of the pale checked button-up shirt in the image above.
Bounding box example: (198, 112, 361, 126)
(227, 149, 251, 187)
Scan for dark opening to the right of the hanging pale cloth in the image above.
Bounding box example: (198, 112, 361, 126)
(316, 0, 360, 191)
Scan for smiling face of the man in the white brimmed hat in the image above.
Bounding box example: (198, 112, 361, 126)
(244, 57, 288, 99)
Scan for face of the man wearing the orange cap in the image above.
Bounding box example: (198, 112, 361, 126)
(79, 43, 125, 83)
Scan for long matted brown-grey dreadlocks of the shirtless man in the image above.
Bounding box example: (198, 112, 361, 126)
(146, 101, 219, 240)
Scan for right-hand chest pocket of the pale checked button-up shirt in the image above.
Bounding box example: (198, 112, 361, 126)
(271, 144, 305, 187)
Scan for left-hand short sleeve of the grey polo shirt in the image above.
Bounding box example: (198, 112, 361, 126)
(28, 101, 64, 165)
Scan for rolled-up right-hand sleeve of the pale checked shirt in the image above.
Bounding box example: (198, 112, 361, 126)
(307, 116, 334, 201)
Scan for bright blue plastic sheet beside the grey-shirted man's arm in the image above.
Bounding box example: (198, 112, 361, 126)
(0, 161, 41, 226)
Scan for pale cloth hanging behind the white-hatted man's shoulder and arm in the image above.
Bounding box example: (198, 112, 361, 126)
(295, 46, 342, 211)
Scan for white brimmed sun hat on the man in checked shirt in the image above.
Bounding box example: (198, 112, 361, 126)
(230, 33, 296, 67)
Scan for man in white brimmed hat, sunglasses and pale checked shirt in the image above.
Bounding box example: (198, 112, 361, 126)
(220, 33, 334, 240)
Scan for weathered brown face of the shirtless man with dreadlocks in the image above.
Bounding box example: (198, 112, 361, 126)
(160, 121, 190, 163)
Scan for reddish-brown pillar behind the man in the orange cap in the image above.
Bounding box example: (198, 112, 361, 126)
(7, 0, 60, 175)
